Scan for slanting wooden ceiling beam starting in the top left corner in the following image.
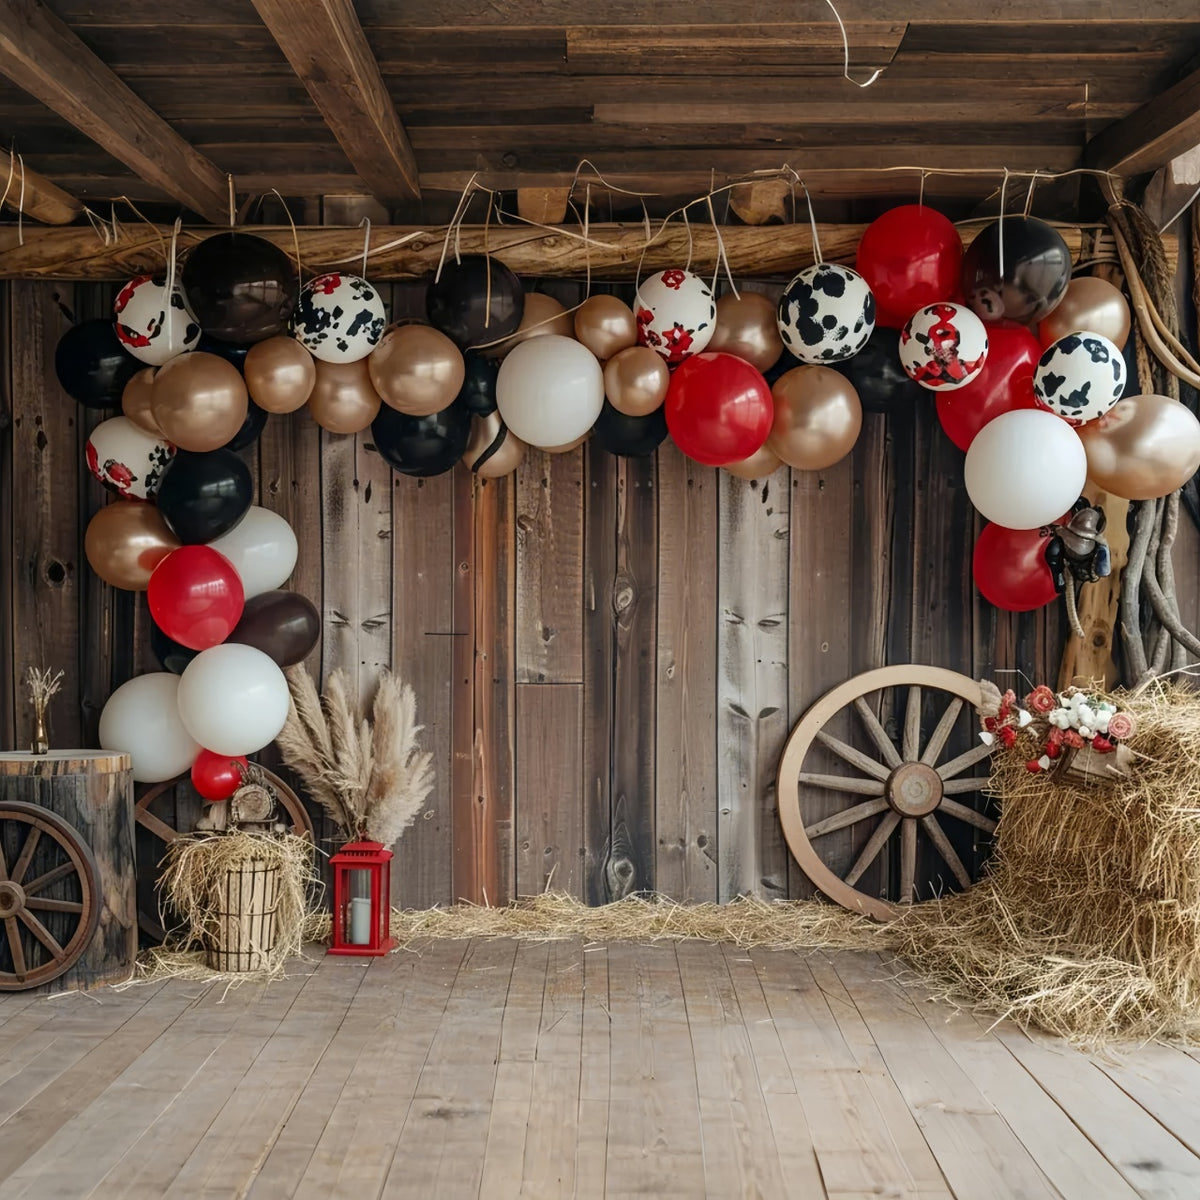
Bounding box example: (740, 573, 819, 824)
(0, 0, 229, 222)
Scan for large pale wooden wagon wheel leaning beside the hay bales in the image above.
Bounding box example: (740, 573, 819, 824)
(779, 665, 996, 920)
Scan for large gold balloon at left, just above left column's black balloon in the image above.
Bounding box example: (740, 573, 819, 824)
(150, 350, 250, 454)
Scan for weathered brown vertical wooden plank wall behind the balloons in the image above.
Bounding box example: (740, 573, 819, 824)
(0, 272, 1200, 907)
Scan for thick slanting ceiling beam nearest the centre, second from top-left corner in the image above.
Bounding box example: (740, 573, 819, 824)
(253, 0, 421, 204)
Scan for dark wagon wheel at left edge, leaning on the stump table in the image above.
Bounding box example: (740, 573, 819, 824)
(0, 800, 101, 991)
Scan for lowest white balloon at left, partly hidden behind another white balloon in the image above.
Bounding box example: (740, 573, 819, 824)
(100, 671, 200, 784)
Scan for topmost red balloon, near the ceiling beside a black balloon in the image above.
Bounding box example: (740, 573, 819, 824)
(854, 204, 962, 329)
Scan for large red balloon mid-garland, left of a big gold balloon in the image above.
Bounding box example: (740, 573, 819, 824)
(664, 352, 775, 467)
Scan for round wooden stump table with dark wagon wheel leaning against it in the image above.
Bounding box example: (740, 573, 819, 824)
(0, 750, 138, 991)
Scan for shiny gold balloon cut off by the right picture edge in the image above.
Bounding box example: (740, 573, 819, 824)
(1075, 396, 1200, 500)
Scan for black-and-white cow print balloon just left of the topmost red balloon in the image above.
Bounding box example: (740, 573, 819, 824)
(778, 263, 875, 364)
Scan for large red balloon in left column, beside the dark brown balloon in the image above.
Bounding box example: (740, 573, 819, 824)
(146, 546, 246, 650)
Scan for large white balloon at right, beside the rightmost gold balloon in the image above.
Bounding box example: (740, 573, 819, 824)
(964, 408, 1087, 529)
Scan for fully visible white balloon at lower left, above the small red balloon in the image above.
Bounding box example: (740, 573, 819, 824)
(179, 642, 289, 755)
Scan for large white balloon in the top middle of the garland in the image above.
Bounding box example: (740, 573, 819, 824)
(496, 334, 604, 448)
